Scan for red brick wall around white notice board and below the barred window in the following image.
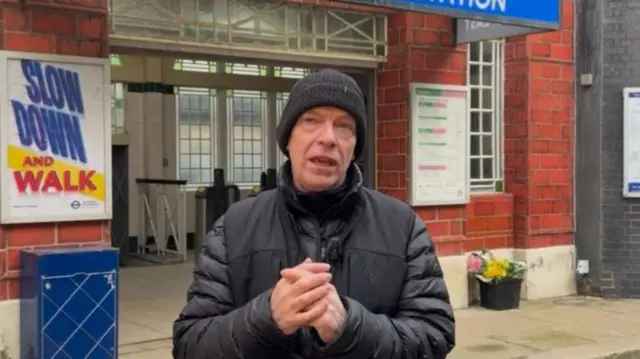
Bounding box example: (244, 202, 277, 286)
(377, 13, 513, 255)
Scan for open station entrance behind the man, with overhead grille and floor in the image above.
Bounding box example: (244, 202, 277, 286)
(110, 0, 386, 344)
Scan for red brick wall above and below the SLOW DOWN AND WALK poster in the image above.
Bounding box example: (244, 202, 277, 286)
(0, 0, 110, 300)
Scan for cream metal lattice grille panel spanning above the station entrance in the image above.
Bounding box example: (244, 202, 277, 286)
(109, 0, 387, 60)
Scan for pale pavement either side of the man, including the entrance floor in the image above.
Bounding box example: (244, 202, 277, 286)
(119, 263, 640, 359)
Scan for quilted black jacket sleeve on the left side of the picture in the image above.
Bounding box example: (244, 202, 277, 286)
(173, 217, 287, 359)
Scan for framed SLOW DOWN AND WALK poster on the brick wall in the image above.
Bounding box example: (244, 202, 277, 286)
(0, 51, 111, 223)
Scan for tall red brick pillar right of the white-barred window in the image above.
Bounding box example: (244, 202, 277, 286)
(504, 0, 575, 252)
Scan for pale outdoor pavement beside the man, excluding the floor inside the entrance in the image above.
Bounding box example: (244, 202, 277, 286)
(120, 297, 640, 359)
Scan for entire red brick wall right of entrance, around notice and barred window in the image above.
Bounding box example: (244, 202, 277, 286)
(377, 0, 574, 255)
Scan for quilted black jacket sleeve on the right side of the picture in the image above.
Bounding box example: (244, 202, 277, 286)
(325, 216, 455, 359)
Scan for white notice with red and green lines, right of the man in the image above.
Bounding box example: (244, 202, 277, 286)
(410, 83, 469, 206)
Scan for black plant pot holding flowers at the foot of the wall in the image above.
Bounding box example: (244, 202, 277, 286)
(478, 279, 522, 310)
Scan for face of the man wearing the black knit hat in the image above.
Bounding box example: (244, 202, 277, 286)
(287, 107, 356, 192)
